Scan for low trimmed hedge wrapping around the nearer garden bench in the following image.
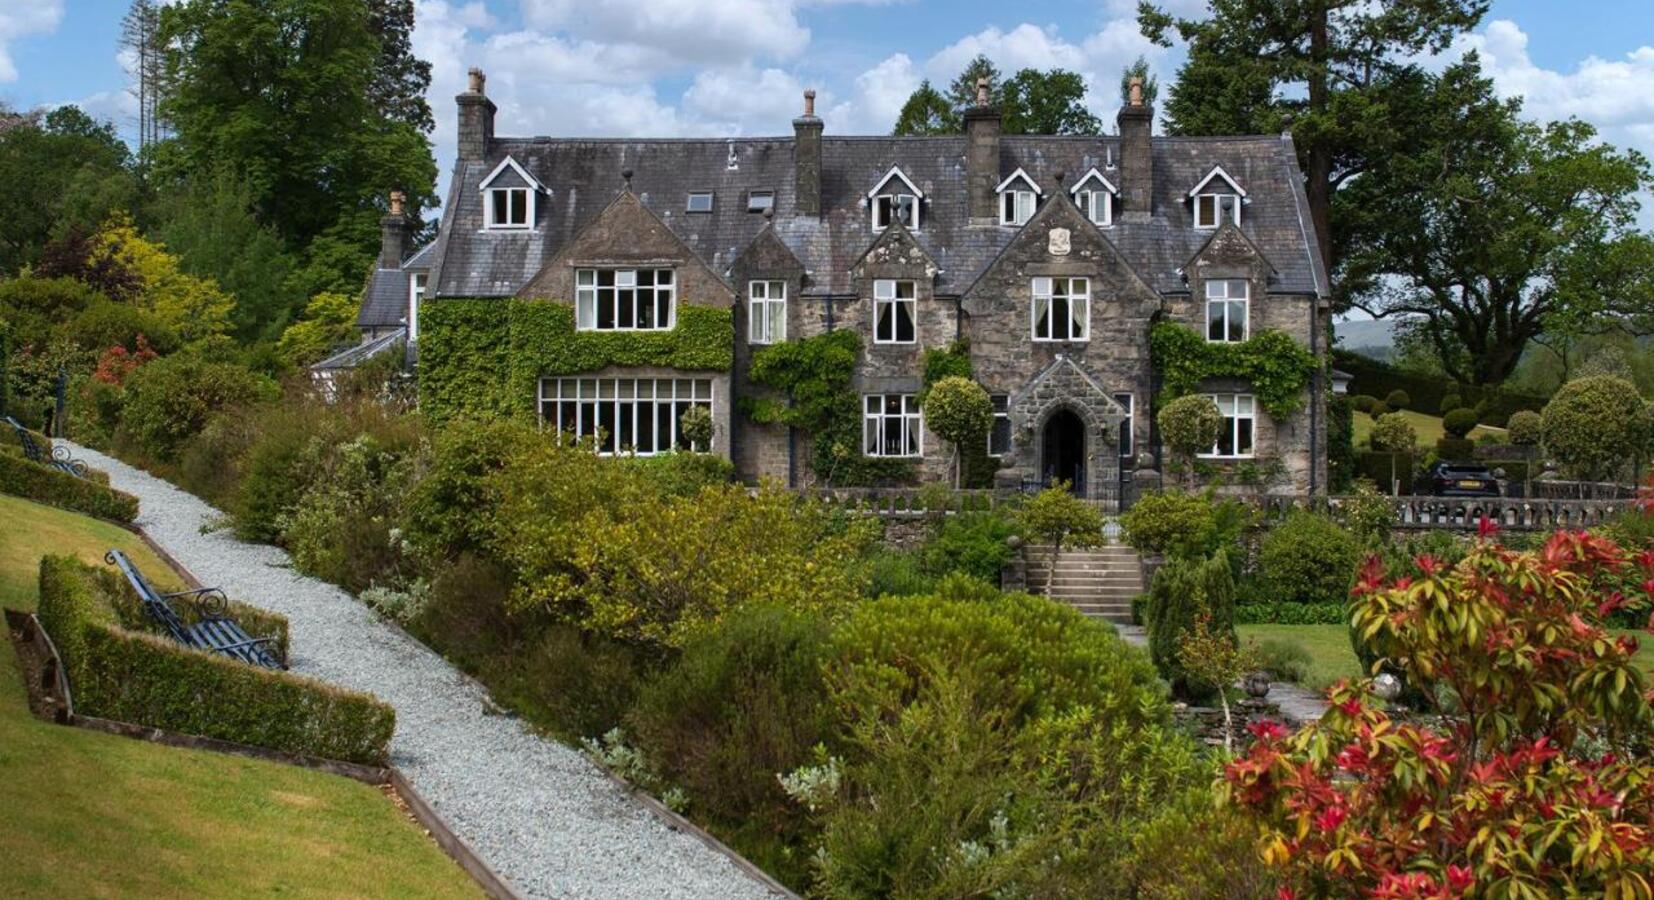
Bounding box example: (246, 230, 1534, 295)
(40, 556, 395, 764)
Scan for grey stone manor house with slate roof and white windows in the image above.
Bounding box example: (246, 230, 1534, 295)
(359, 69, 1328, 498)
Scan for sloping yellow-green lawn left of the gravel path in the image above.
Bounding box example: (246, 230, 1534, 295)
(0, 496, 480, 897)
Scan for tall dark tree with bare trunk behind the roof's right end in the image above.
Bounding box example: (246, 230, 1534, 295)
(1138, 0, 1487, 270)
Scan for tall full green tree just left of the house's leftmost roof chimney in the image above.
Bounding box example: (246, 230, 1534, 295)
(157, 0, 437, 284)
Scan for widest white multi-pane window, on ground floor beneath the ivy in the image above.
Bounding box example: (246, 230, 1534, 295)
(539, 379, 713, 457)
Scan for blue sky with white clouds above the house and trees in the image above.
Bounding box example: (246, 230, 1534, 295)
(0, 0, 1654, 198)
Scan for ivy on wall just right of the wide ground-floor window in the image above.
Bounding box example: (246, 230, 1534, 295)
(741, 331, 915, 486)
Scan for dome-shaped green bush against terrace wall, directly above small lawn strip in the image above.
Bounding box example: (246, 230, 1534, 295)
(1257, 510, 1361, 604)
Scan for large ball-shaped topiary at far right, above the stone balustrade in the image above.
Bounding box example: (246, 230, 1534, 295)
(1540, 376, 1646, 480)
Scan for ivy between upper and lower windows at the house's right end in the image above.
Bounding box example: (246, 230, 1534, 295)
(1150, 323, 1318, 419)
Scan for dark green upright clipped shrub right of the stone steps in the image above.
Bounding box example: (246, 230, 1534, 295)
(1146, 551, 1236, 701)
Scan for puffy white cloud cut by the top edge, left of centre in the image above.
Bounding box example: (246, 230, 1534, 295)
(523, 0, 810, 65)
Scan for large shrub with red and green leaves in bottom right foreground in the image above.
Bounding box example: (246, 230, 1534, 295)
(1224, 529, 1654, 898)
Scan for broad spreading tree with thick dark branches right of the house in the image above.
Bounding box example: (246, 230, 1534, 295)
(1338, 55, 1654, 384)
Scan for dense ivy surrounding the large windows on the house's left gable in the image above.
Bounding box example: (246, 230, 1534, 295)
(418, 298, 734, 420)
